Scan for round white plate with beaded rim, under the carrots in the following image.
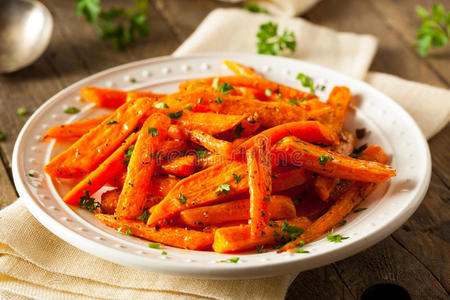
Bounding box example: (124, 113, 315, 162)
(12, 53, 431, 278)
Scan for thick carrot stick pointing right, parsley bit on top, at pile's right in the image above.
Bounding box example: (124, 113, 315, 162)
(274, 137, 396, 182)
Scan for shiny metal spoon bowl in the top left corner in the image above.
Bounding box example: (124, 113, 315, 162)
(0, 0, 53, 73)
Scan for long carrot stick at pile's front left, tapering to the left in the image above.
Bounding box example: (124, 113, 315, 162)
(95, 214, 214, 250)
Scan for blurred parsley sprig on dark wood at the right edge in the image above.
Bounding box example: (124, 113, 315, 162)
(416, 3, 450, 56)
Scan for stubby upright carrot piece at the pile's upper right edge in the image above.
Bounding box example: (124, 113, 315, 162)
(327, 86, 352, 133)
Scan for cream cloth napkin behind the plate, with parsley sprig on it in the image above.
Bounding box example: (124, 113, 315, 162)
(174, 8, 450, 138)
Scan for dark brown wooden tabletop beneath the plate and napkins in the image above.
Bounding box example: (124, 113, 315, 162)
(0, 0, 450, 299)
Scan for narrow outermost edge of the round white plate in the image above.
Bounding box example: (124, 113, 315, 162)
(12, 52, 432, 279)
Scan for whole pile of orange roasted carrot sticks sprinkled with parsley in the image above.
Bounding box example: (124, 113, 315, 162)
(45, 61, 396, 253)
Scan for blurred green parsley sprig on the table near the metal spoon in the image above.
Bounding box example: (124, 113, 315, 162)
(75, 0, 149, 50)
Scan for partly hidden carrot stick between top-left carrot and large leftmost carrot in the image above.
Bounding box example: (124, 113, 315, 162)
(43, 115, 109, 140)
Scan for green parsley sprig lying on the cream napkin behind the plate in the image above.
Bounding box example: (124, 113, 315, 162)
(256, 22, 297, 55)
